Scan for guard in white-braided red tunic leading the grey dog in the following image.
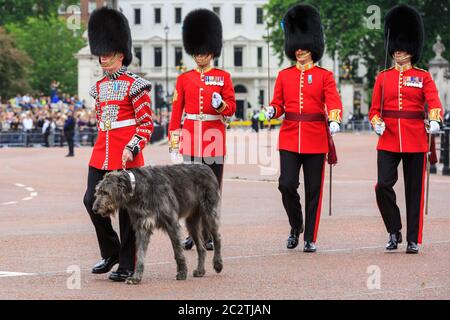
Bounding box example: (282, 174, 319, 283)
(84, 8, 153, 281)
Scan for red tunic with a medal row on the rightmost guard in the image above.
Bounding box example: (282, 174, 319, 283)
(369, 65, 443, 152)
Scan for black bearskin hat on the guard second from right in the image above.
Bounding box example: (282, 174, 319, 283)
(282, 4, 325, 62)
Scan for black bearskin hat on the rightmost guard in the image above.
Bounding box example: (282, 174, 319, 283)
(384, 4, 424, 63)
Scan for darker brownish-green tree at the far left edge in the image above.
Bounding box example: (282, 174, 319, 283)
(0, 27, 31, 97)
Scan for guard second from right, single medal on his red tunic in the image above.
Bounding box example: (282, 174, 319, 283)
(266, 4, 342, 252)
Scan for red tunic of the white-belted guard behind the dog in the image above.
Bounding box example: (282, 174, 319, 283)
(169, 68, 236, 158)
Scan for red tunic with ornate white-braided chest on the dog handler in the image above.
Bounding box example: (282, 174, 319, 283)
(89, 67, 153, 170)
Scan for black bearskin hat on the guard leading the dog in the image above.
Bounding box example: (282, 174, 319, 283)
(88, 7, 133, 66)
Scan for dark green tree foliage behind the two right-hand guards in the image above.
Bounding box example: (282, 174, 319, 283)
(266, 0, 450, 87)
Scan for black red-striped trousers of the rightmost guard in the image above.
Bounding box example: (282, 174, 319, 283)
(375, 150, 426, 243)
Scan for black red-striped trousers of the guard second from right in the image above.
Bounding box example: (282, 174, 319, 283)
(278, 150, 325, 242)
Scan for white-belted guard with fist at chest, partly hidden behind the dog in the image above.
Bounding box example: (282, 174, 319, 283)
(169, 9, 236, 250)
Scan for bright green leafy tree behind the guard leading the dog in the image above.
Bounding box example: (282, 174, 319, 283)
(6, 16, 85, 94)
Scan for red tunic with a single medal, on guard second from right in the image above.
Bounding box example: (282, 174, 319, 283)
(271, 63, 342, 154)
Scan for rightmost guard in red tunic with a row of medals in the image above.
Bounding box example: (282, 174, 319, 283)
(369, 5, 443, 253)
